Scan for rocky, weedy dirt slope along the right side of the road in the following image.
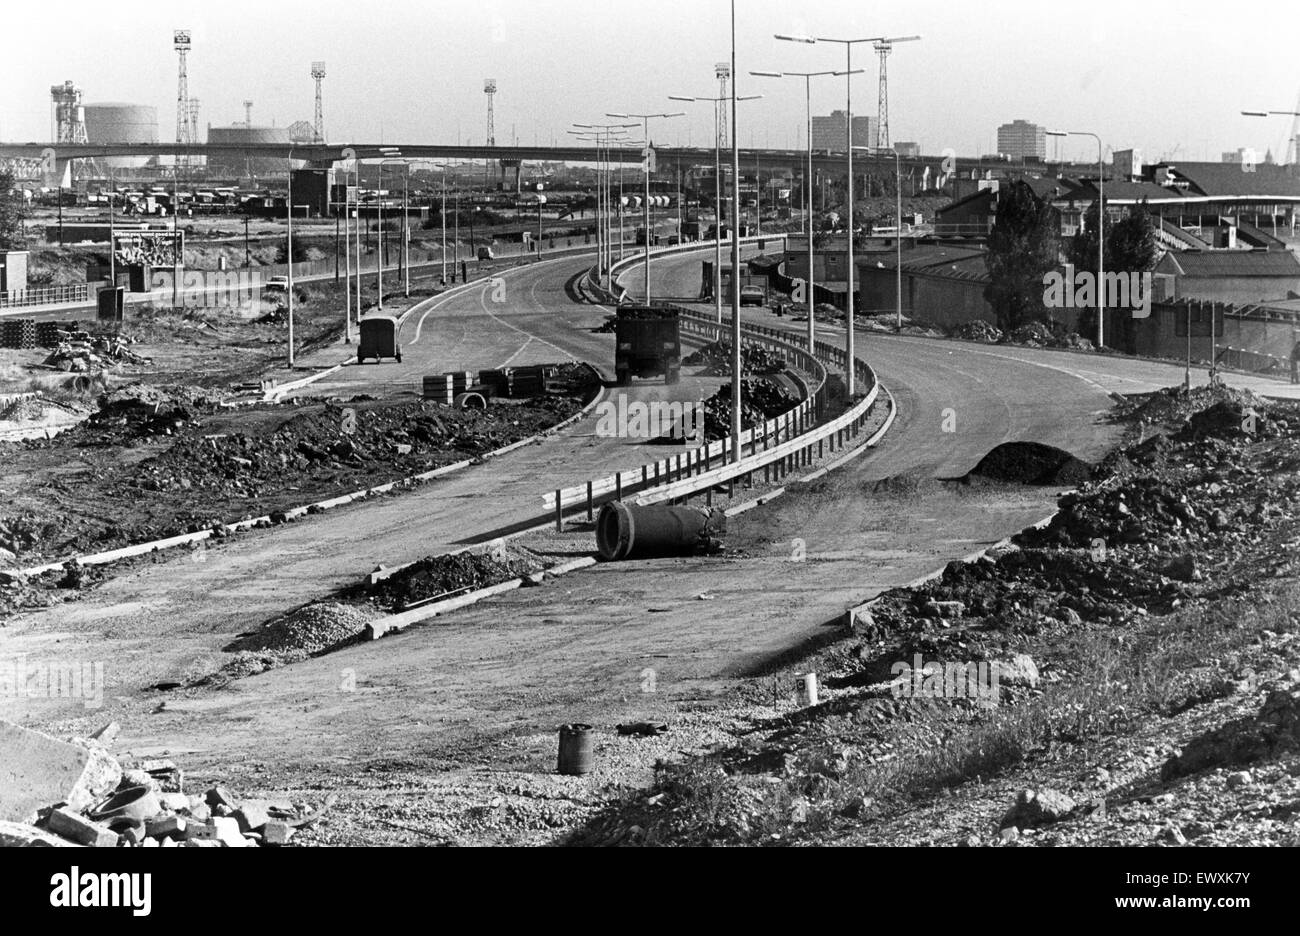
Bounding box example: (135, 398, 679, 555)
(573, 390, 1300, 845)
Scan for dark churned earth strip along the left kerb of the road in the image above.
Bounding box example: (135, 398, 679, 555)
(0, 385, 582, 574)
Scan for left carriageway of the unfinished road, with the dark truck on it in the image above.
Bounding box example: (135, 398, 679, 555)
(0, 248, 718, 696)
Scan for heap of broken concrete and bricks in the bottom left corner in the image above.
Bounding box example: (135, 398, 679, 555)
(0, 722, 324, 848)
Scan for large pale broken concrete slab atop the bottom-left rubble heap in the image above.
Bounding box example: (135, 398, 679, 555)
(0, 720, 122, 823)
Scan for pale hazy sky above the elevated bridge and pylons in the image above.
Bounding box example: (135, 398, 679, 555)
(0, 0, 1300, 161)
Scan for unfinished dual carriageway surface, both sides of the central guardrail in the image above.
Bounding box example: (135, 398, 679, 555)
(4, 239, 1289, 806)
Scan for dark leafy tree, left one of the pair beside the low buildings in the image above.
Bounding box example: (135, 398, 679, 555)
(984, 182, 1061, 332)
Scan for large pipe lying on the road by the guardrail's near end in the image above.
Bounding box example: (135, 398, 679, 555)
(595, 501, 727, 562)
